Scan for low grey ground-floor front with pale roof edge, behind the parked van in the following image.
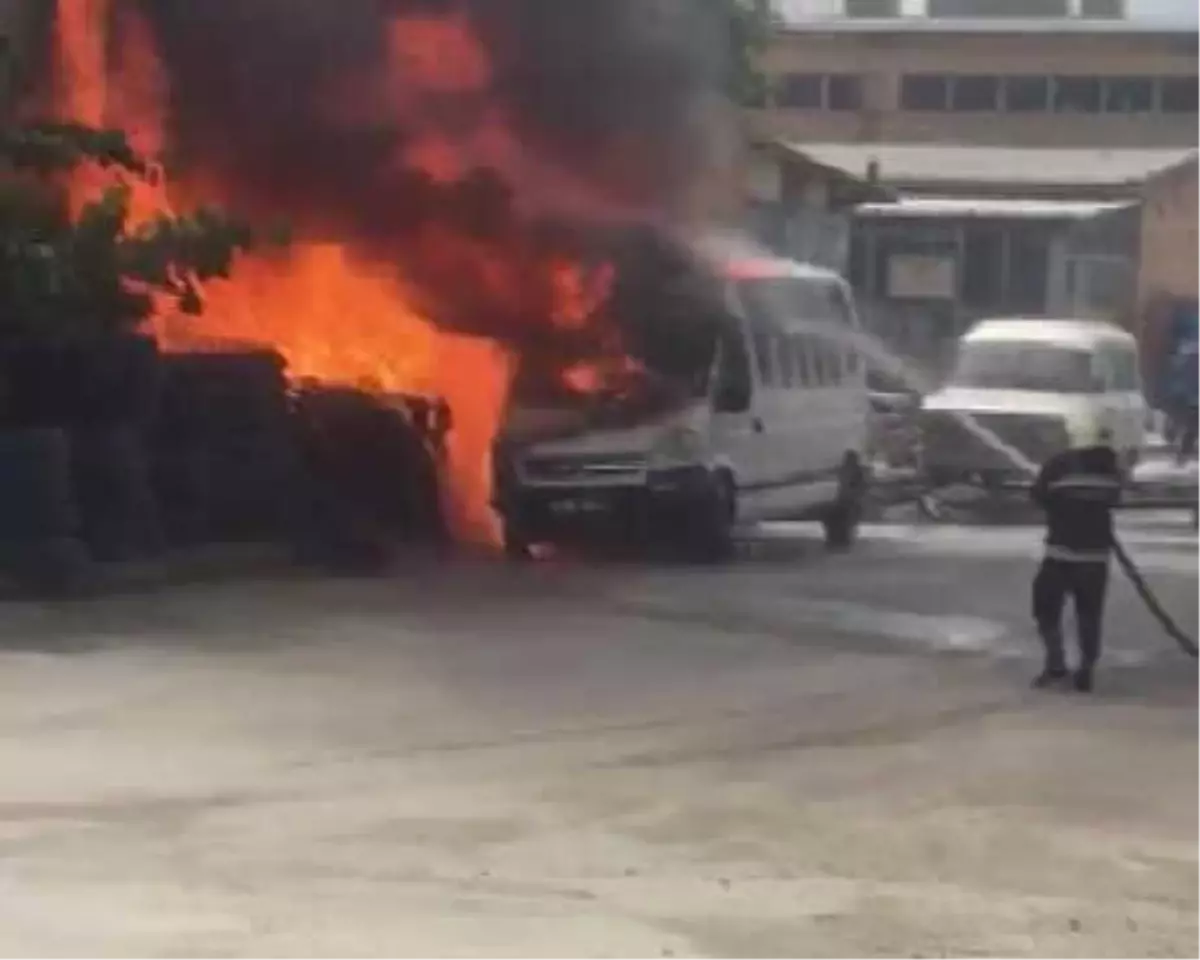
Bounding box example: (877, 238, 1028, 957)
(847, 198, 1141, 377)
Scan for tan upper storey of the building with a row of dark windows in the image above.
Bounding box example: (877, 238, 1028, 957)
(752, 15, 1200, 148)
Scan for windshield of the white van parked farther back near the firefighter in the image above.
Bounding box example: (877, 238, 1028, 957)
(950, 341, 1098, 394)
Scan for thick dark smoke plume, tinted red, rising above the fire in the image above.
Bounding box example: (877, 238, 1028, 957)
(70, 0, 725, 355)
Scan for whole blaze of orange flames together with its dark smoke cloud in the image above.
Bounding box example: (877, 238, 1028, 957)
(38, 0, 758, 552)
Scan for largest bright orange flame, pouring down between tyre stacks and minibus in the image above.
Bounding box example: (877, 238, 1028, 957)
(156, 244, 510, 542)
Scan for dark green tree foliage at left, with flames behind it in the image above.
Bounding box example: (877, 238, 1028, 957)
(0, 124, 276, 338)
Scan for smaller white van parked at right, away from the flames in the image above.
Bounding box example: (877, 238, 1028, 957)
(920, 318, 1146, 486)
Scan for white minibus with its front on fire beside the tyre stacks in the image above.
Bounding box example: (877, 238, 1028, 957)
(494, 249, 870, 558)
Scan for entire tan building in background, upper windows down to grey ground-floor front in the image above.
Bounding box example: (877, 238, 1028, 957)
(751, 10, 1200, 381)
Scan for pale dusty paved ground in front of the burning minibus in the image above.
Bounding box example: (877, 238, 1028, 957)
(0, 515, 1200, 960)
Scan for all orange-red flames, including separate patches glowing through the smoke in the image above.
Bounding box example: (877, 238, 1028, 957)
(48, 0, 633, 540)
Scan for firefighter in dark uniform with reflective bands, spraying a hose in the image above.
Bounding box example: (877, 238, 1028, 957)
(1033, 431, 1122, 692)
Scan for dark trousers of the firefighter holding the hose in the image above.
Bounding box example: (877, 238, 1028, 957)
(1033, 557, 1109, 674)
